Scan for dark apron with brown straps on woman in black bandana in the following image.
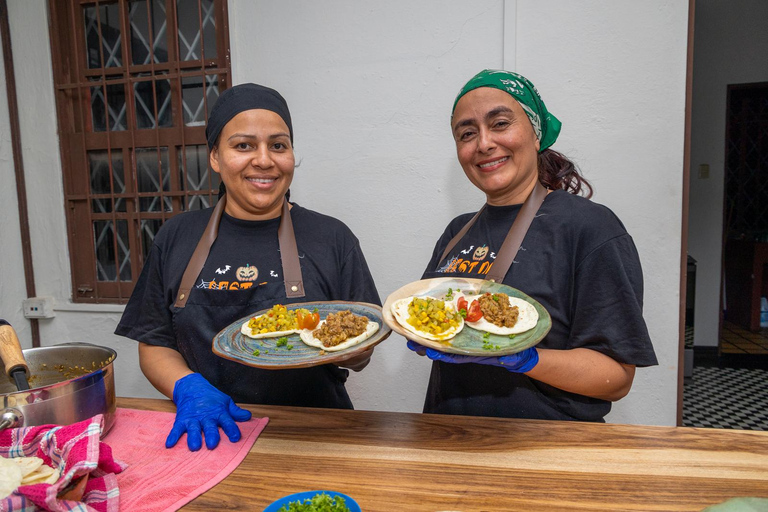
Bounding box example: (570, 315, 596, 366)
(168, 195, 352, 409)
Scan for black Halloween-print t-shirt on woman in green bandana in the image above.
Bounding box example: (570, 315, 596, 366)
(423, 190, 658, 421)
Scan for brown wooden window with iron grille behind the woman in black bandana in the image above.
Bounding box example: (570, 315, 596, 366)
(49, 0, 226, 303)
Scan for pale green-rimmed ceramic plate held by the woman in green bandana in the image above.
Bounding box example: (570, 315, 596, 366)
(382, 277, 552, 356)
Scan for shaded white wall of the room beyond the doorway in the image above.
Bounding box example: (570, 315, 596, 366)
(688, 0, 768, 346)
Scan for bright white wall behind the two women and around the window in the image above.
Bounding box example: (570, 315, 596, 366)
(0, 0, 687, 425)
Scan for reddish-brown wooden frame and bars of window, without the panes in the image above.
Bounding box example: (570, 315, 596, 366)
(48, 0, 231, 303)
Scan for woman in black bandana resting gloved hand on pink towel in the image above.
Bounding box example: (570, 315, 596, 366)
(115, 84, 380, 450)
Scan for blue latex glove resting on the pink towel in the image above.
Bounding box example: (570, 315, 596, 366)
(165, 373, 251, 452)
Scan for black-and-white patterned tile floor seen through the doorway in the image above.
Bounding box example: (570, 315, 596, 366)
(683, 322, 768, 430)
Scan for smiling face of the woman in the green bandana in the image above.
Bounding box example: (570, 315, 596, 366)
(451, 87, 540, 206)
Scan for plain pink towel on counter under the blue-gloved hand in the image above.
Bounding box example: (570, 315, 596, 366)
(103, 408, 269, 512)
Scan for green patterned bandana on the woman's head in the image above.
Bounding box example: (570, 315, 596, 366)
(451, 69, 561, 153)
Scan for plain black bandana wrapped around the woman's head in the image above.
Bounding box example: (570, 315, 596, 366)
(205, 84, 293, 149)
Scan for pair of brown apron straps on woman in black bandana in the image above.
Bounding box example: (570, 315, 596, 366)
(174, 194, 304, 308)
